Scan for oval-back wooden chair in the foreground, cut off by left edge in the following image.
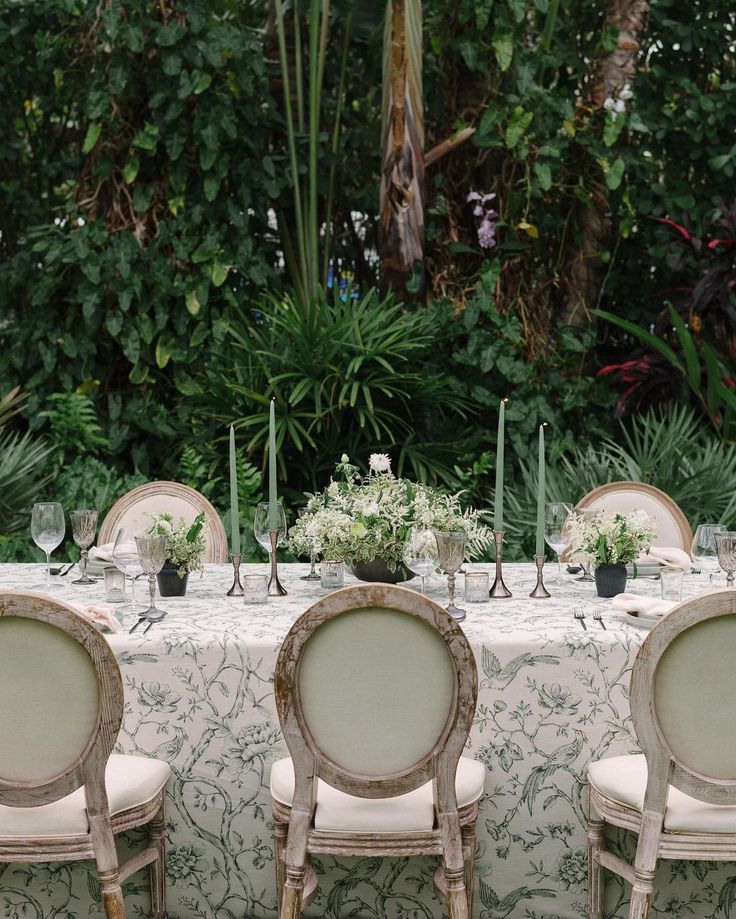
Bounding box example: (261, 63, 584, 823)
(0, 590, 170, 919)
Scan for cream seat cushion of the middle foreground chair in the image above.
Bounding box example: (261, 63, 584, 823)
(271, 756, 486, 833)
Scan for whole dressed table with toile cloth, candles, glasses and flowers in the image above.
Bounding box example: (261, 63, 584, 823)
(10, 403, 736, 919)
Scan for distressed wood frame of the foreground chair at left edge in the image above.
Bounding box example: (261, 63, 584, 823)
(0, 590, 166, 919)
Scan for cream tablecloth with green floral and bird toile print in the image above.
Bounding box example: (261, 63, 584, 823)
(0, 565, 736, 919)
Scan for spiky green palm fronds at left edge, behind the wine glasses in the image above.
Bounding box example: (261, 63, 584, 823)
(0, 386, 52, 536)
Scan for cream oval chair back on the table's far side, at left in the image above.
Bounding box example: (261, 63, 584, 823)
(98, 482, 228, 563)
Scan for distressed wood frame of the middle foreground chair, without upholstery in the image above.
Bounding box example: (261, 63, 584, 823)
(272, 584, 478, 919)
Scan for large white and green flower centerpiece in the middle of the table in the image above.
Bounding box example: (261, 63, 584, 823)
(289, 453, 493, 581)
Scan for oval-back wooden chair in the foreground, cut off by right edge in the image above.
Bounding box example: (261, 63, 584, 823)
(588, 590, 736, 919)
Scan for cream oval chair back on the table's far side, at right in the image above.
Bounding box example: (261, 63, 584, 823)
(576, 482, 693, 553)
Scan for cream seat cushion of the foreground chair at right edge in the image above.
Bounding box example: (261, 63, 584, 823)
(588, 754, 736, 834)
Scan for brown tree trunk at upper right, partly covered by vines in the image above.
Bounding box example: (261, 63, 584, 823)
(564, 0, 649, 325)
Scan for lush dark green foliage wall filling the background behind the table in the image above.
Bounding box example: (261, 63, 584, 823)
(0, 0, 736, 554)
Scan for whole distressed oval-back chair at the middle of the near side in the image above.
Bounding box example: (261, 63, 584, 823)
(271, 584, 485, 919)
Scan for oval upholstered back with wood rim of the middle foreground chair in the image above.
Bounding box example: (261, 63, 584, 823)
(276, 584, 477, 802)
